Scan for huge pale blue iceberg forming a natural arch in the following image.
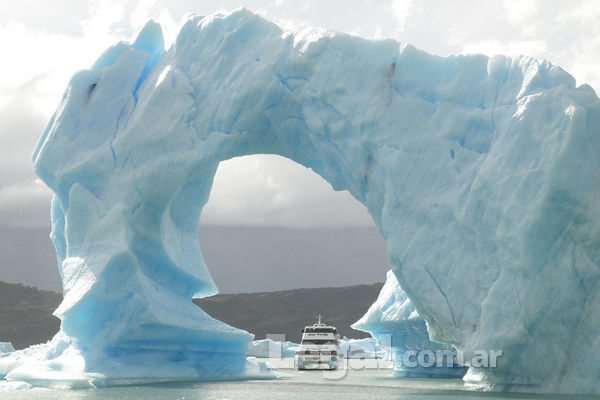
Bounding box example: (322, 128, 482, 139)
(0, 9, 600, 393)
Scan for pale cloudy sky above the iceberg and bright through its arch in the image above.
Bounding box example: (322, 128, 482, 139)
(0, 0, 600, 228)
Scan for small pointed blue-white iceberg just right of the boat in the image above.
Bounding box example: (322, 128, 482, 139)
(352, 270, 467, 378)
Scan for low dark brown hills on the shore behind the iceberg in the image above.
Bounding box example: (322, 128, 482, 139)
(0, 282, 383, 349)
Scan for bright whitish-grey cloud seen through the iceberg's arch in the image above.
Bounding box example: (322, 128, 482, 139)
(202, 155, 373, 228)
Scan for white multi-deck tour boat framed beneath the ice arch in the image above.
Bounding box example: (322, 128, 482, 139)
(295, 314, 341, 370)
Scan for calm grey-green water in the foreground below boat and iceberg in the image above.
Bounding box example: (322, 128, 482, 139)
(0, 360, 600, 400)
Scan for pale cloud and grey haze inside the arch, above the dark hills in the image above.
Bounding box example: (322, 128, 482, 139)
(199, 155, 389, 294)
